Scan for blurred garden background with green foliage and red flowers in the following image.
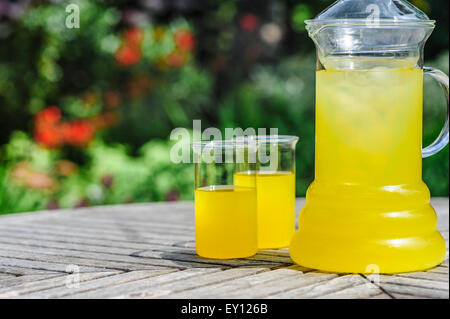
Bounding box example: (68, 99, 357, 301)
(0, 0, 449, 214)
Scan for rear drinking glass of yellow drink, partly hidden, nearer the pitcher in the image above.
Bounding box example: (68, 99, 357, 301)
(235, 135, 298, 249)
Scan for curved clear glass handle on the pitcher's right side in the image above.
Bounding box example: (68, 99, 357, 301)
(422, 67, 449, 158)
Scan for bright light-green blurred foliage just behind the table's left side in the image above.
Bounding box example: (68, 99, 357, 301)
(0, 131, 194, 214)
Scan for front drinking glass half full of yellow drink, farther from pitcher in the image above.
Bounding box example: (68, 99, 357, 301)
(192, 141, 258, 259)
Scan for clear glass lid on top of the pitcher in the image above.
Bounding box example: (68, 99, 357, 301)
(305, 0, 435, 32)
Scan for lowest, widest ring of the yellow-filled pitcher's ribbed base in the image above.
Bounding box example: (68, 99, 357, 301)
(290, 231, 445, 273)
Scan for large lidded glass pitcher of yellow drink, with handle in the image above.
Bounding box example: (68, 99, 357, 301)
(290, 0, 449, 273)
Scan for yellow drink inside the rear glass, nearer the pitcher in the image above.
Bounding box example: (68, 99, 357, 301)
(234, 172, 295, 249)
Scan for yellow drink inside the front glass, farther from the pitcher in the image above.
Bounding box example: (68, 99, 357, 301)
(195, 186, 258, 259)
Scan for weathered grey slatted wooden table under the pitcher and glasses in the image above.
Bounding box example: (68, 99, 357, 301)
(0, 198, 449, 298)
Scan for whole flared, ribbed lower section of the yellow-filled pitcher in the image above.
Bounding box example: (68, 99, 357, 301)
(289, 181, 445, 273)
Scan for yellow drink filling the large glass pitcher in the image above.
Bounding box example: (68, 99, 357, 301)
(290, 68, 445, 273)
